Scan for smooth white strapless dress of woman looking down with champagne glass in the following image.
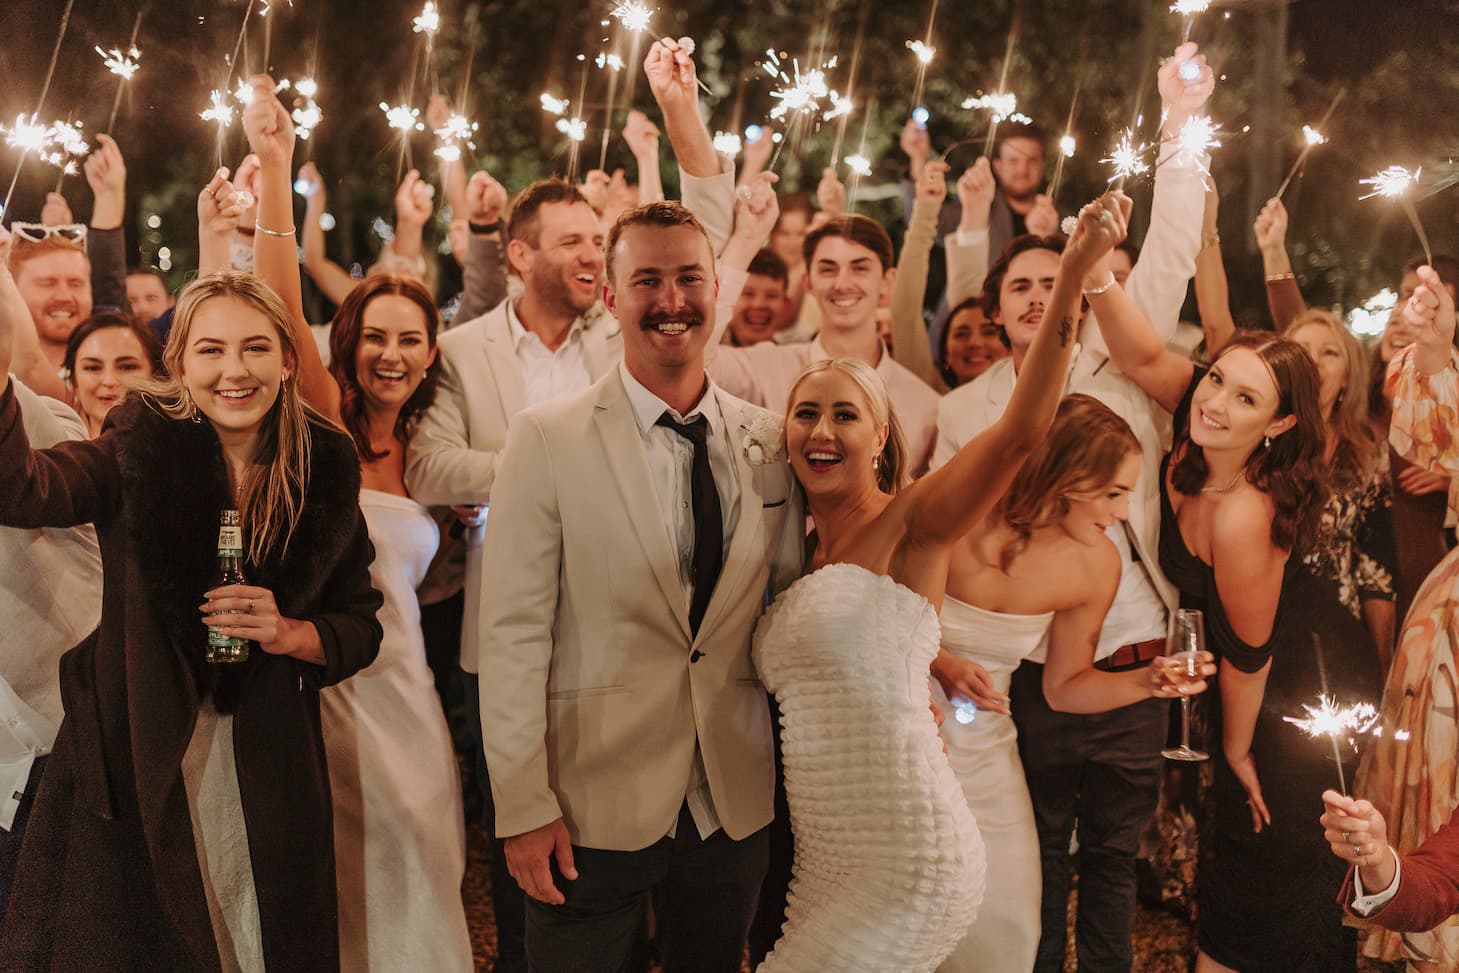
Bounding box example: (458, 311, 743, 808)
(932, 597, 1053, 973)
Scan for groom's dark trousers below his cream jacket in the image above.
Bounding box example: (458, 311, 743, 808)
(527, 805, 767, 973)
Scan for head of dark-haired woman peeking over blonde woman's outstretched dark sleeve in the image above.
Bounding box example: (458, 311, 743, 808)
(61, 311, 162, 439)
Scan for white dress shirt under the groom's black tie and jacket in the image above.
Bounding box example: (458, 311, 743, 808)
(619, 362, 740, 837)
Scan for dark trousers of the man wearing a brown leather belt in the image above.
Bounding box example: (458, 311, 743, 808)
(1011, 662, 1170, 973)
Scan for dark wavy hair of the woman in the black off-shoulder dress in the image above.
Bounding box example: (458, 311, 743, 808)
(1170, 331, 1328, 554)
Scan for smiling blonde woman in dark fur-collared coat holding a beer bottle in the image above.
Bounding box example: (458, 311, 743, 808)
(0, 223, 381, 970)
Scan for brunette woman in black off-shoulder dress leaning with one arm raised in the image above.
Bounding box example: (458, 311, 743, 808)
(1085, 261, 1371, 973)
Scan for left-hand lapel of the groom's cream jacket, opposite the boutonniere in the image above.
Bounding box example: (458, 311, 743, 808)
(594, 375, 702, 639)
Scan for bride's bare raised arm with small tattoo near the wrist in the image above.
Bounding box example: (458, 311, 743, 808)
(905, 190, 1131, 546)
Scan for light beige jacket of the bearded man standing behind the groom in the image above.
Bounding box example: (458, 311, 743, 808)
(406, 301, 623, 672)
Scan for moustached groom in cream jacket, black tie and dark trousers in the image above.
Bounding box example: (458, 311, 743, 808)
(480, 203, 804, 973)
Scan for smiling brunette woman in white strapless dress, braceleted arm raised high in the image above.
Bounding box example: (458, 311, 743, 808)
(245, 78, 473, 973)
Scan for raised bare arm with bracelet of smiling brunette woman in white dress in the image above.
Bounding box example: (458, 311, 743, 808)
(244, 74, 340, 422)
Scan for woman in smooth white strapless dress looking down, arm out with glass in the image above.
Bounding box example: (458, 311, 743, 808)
(932, 395, 1214, 973)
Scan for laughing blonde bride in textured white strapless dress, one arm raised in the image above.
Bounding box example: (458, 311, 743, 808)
(754, 191, 1131, 973)
